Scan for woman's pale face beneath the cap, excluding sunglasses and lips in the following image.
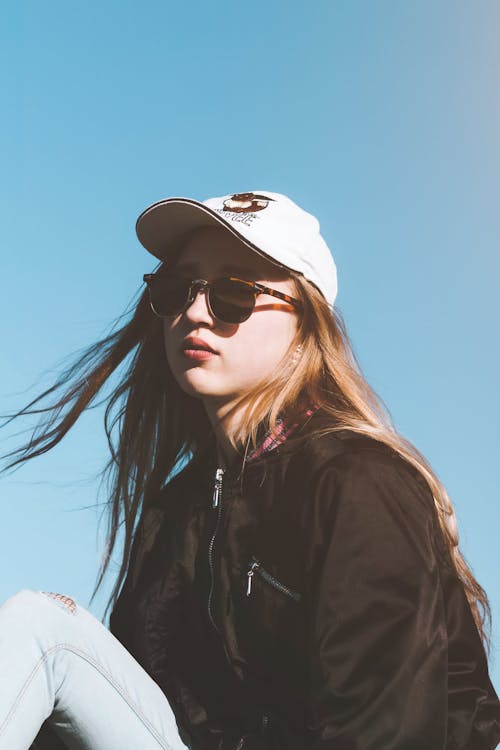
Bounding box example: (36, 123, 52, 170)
(163, 227, 297, 414)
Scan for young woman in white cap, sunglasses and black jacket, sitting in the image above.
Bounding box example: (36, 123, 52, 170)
(0, 191, 500, 750)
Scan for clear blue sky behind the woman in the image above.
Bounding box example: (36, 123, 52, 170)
(0, 0, 500, 689)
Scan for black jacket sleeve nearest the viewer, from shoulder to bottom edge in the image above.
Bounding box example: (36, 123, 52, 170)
(309, 451, 500, 750)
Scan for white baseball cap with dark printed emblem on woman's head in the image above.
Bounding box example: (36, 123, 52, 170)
(136, 190, 337, 307)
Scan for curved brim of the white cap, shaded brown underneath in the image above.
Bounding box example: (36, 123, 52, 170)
(135, 198, 287, 268)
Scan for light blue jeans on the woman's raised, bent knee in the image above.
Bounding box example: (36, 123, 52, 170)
(0, 589, 188, 750)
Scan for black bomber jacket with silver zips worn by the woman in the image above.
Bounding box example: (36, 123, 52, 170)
(29, 415, 500, 750)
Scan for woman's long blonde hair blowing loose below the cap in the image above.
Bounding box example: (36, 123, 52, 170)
(0, 262, 491, 653)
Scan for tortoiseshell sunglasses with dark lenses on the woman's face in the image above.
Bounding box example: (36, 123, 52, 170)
(144, 268, 302, 323)
